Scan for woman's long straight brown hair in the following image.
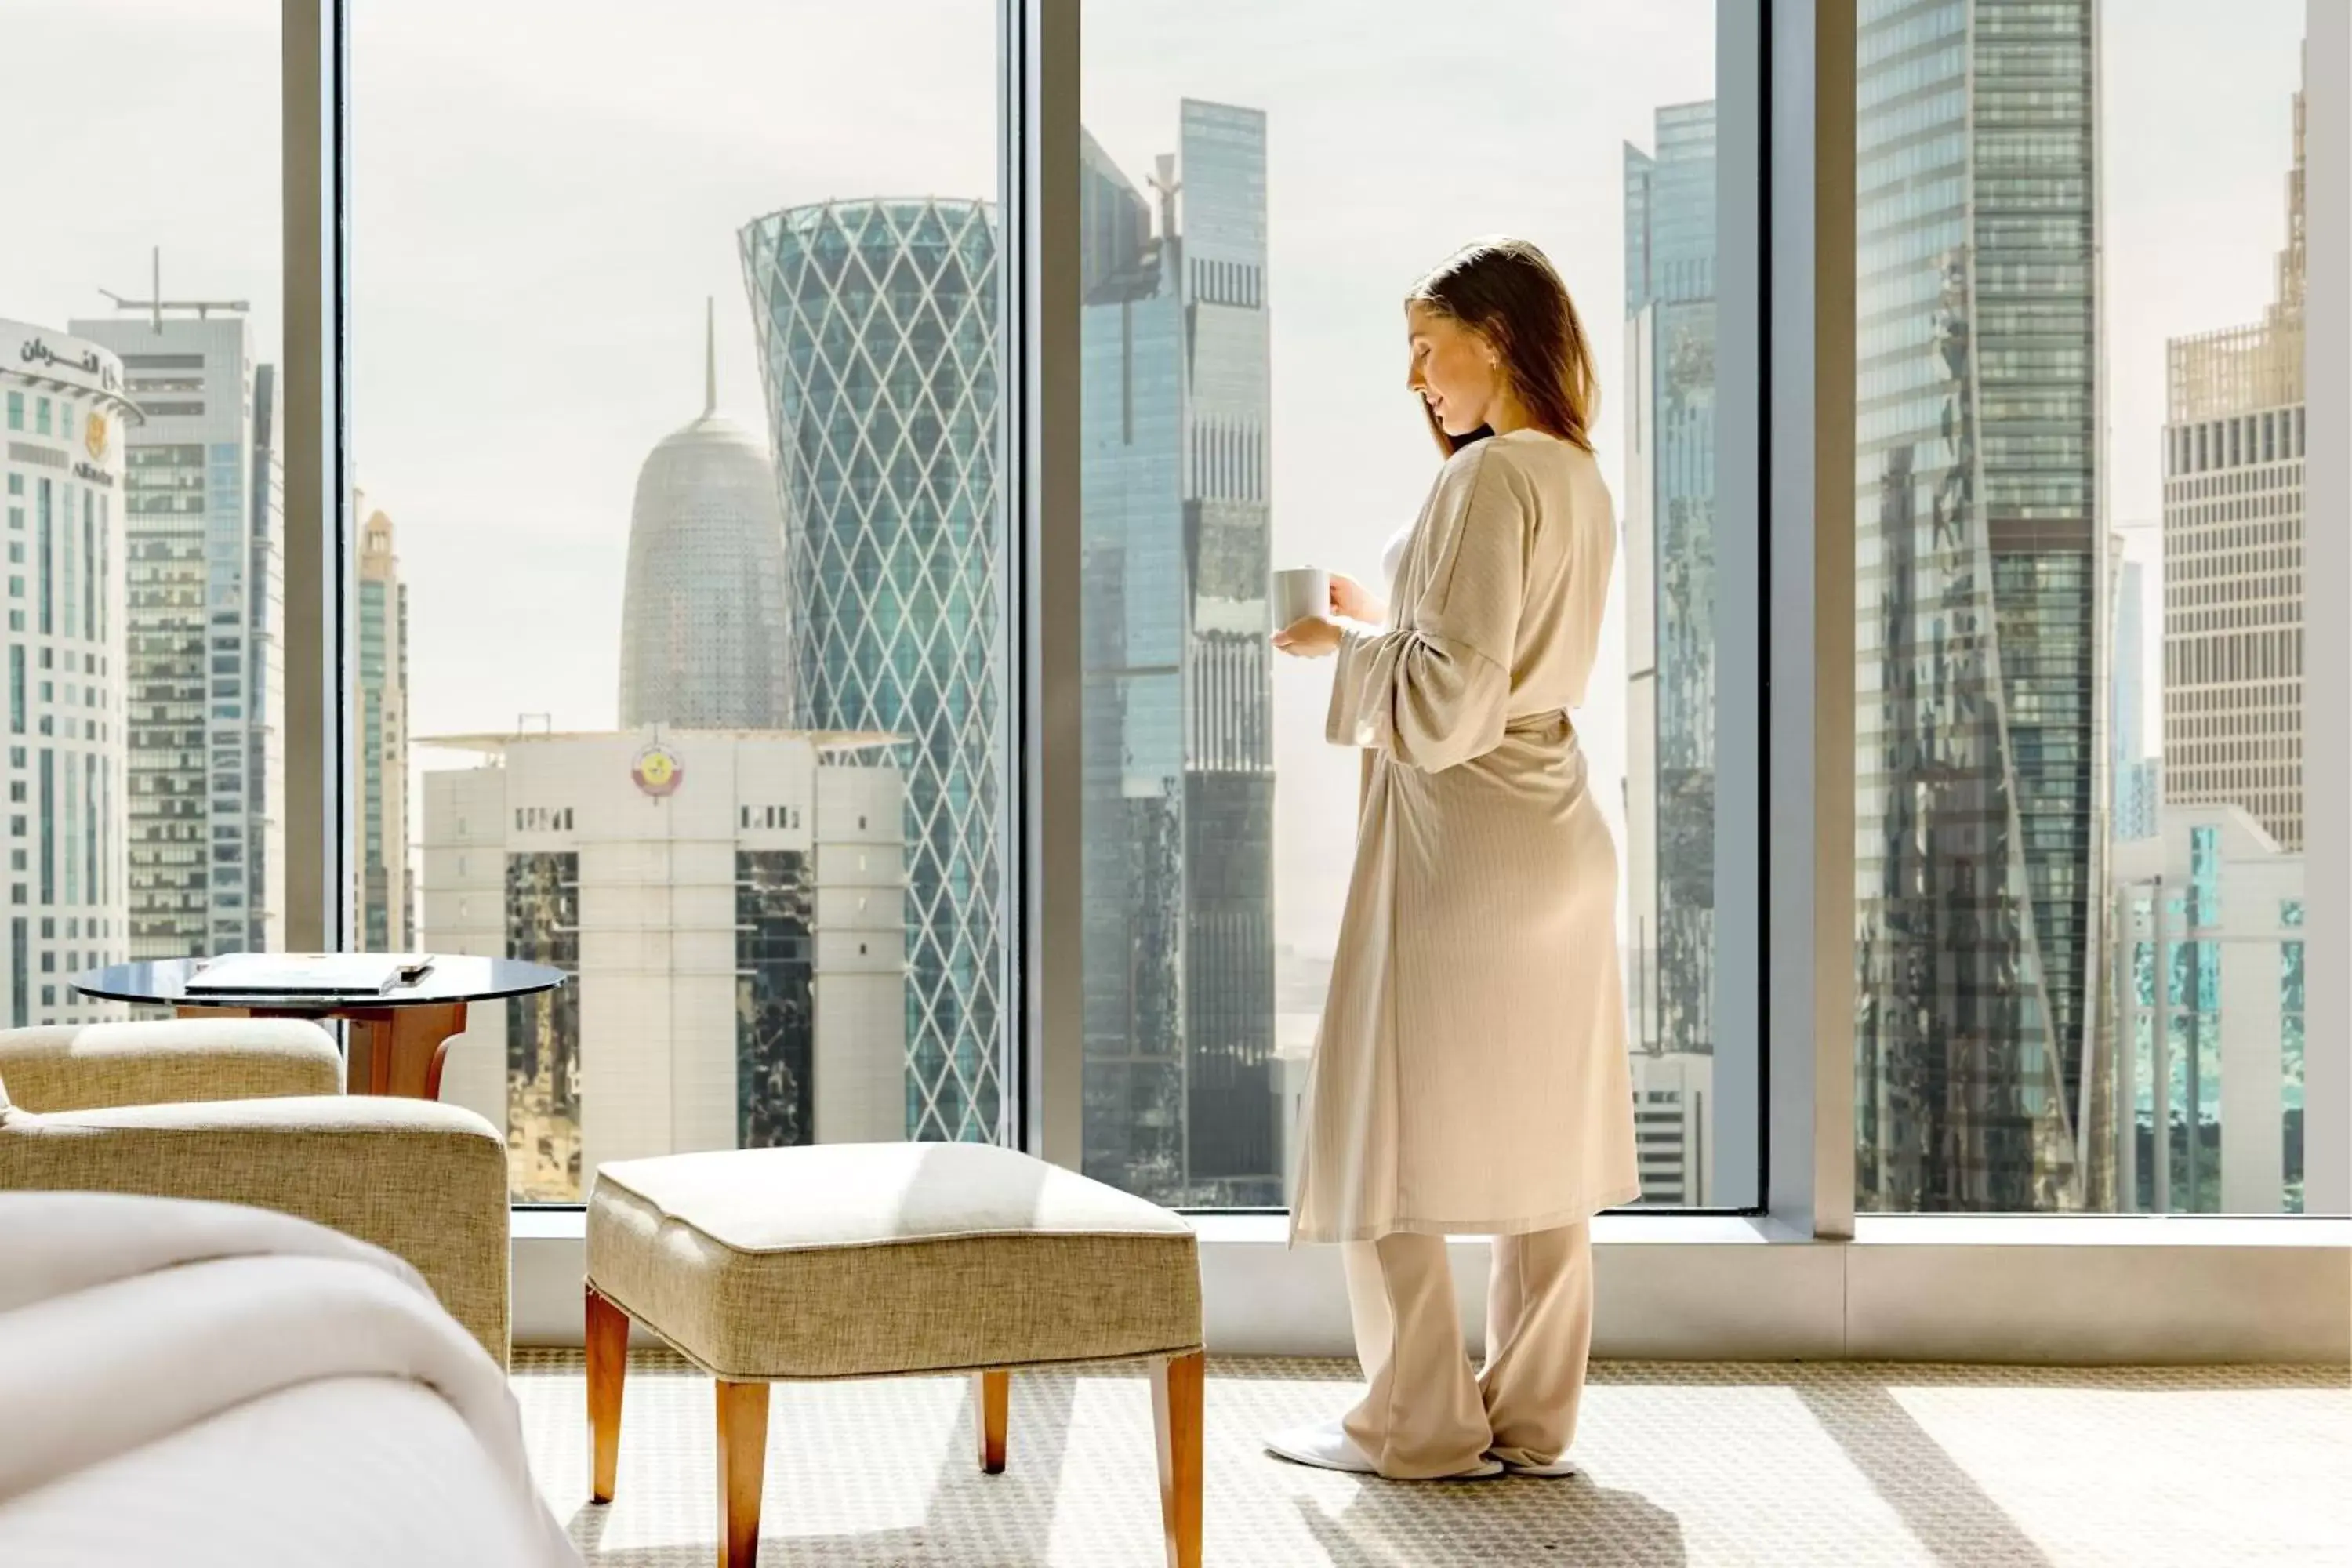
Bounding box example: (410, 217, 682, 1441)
(1404, 238, 1602, 454)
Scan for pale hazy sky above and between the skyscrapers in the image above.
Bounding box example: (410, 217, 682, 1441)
(0, 0, 2303, 964)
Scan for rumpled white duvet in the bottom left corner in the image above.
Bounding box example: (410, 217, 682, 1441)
(0, 1192, 579, 1568)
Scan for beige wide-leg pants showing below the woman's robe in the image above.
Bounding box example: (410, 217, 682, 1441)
(1343, 1225, 1592, 1481)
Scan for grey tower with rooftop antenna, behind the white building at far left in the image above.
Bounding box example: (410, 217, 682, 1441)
(73, 288, 285, 959)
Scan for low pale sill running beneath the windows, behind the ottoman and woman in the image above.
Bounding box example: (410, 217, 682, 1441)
(513, 1208, 2352, 1366)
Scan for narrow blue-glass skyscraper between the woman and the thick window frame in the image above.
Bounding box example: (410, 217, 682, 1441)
(1625, 103, 1717, 1203)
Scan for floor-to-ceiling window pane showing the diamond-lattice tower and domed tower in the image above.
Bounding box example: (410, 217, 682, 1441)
(348, 0, 1007, 1201)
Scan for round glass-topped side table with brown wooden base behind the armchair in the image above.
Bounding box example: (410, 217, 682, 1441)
(73, 954, 569, 1100)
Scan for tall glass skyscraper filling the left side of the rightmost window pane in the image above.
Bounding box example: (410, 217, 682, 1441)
(1856, 0, 2107, 1210)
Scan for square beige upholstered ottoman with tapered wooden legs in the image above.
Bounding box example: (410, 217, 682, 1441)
(588, 1142, 1204, 1568)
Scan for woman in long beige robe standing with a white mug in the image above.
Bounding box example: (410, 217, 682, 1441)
(1268, 240, 1639, 1479)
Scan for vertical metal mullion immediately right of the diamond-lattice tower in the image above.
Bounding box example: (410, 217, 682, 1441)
(997, 0, 1084, 1171)
